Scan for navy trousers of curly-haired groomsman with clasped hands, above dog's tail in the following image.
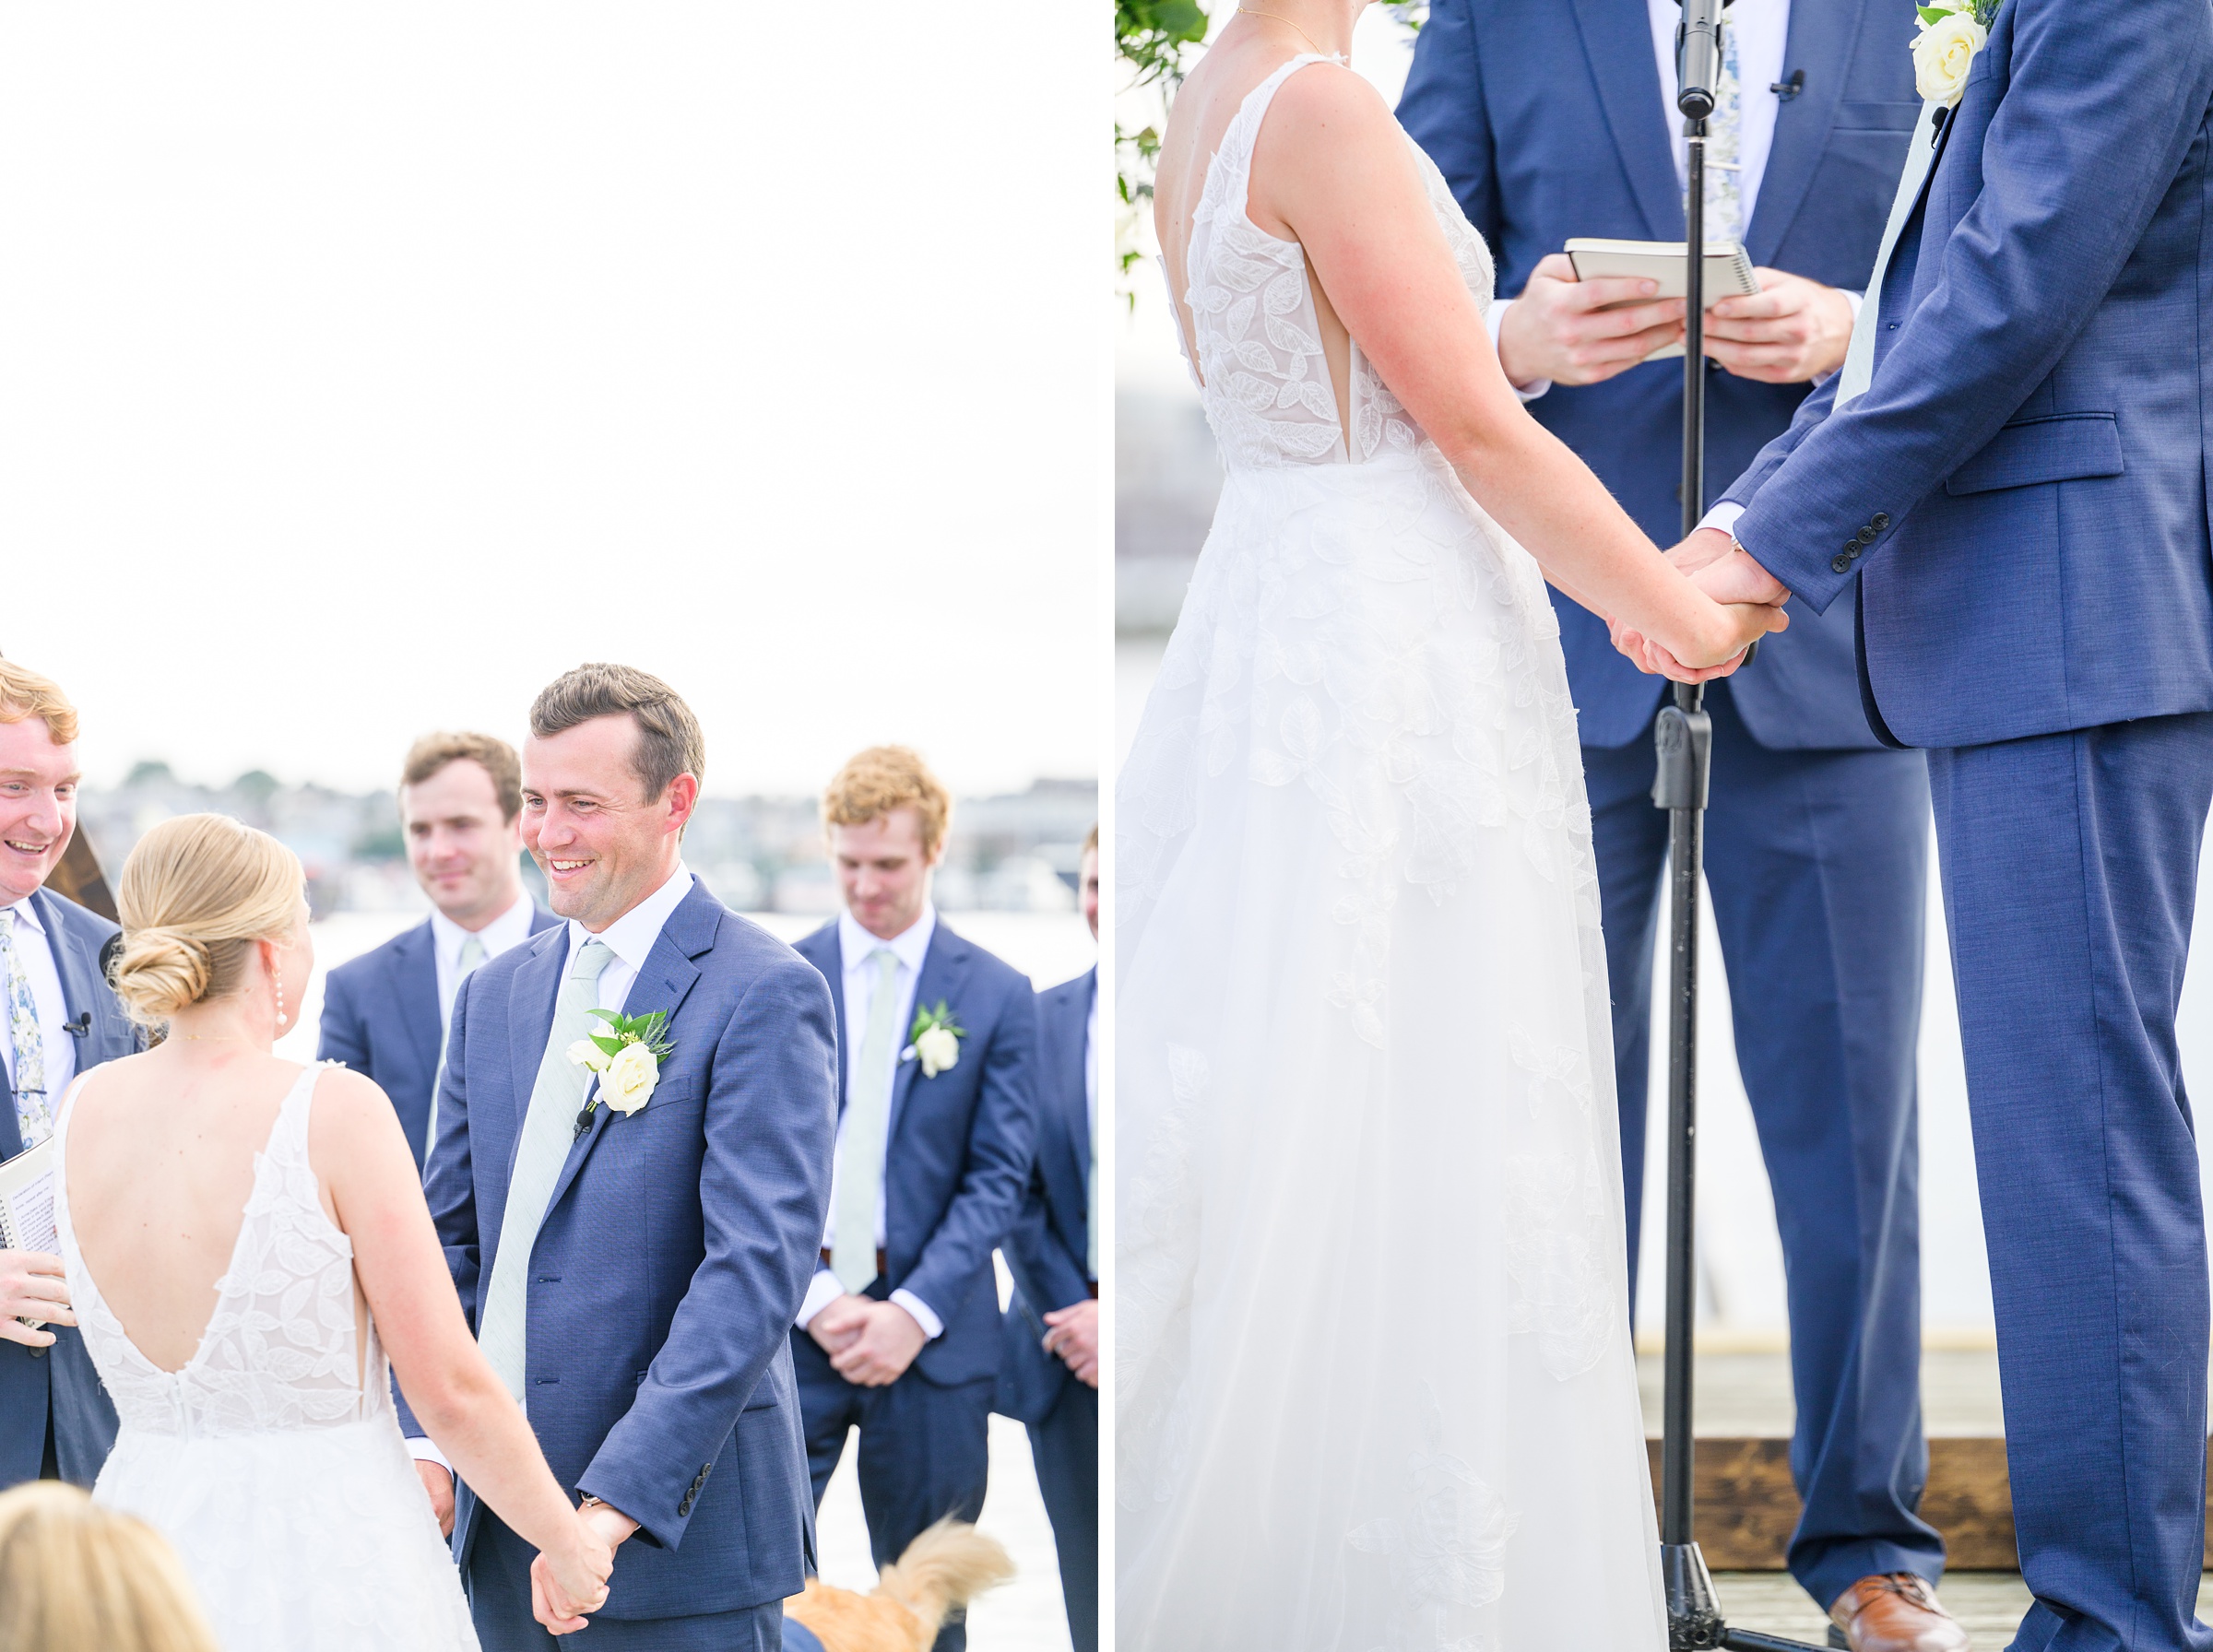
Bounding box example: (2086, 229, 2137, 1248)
(792, 1327, 998, 1652)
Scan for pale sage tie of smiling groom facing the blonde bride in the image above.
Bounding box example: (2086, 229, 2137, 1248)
(476, 940, 615, 1411)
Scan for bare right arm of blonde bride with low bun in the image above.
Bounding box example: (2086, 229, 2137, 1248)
(308, 1068, 613, 1628)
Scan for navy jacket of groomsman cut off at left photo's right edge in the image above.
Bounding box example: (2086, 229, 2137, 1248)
(998, 966, 1100, 1422)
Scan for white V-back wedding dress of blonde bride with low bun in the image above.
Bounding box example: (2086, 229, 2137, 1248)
(55, 1066, 476, 1652)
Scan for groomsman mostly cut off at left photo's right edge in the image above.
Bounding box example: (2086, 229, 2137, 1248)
(998, 827, 1100, 1652)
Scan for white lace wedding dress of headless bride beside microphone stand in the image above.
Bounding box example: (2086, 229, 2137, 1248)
(1116, 57, 1666, 1652)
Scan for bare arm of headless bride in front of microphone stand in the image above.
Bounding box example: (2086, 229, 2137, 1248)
(1250, 66, 1786, 666)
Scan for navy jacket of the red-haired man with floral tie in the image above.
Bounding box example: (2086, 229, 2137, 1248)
(0, 889, 144, 1486)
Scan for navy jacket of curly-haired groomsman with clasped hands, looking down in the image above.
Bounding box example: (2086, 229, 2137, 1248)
(792, 918, 1038, 1385)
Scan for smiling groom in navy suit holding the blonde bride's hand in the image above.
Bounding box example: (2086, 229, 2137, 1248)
(408, 666, 836, 1652)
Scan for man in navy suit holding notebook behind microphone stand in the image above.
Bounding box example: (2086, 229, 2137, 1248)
(1399, 0, 1963, 1652)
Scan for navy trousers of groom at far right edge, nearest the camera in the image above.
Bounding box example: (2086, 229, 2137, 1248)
(1930, 712, 2213, 1652)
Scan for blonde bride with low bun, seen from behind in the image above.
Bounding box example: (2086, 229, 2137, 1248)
(55, 814, 613, 1652)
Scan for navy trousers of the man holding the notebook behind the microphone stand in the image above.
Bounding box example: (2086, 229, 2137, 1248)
(1582, 683, 1943, 1608)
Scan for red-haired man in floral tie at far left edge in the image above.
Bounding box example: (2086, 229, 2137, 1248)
(0, 659, 139, 1486)
